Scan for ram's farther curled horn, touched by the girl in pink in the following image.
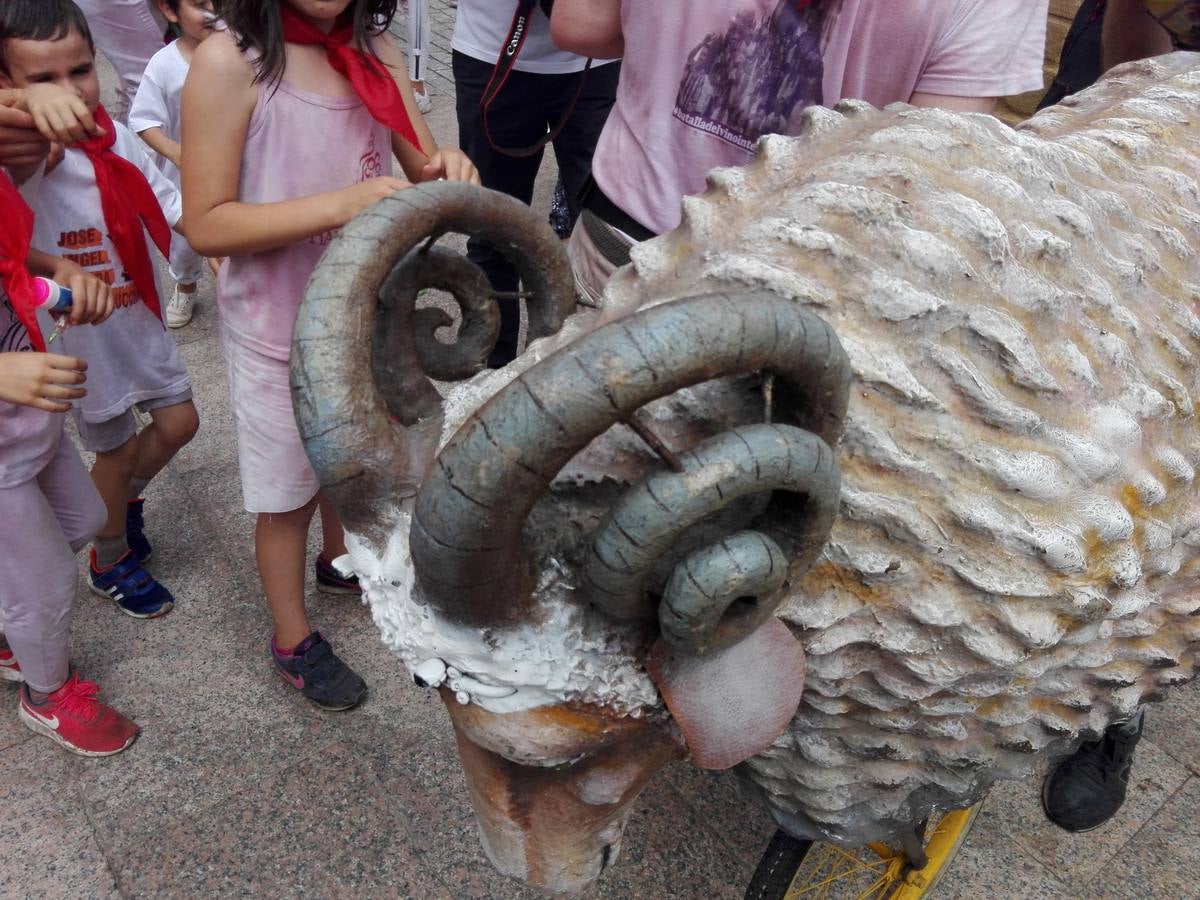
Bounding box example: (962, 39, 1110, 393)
(292, 181, 575, 545)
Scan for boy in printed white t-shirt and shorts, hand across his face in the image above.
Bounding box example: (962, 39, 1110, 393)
(0, 0, 198, 618)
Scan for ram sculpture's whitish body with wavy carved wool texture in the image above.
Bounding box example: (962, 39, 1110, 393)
(604, 54, 1200, 842)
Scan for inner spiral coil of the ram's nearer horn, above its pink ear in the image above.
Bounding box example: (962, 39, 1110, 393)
(583, 425, 841, 653)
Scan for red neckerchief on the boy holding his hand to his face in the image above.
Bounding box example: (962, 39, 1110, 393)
(72, 106, 170, 318)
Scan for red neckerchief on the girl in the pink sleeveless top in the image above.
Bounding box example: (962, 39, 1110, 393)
(280, 4, 425, 154)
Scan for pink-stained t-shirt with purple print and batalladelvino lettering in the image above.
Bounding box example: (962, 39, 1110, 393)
(592, 0, 1049, 233)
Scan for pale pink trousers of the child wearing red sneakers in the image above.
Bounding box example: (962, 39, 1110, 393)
(0, 437, 104, 700)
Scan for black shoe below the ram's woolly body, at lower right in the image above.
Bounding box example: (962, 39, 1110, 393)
(1042, 713, 1146, 832)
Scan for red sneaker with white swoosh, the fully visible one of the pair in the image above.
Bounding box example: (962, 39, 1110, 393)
(19, 672, 140, 756)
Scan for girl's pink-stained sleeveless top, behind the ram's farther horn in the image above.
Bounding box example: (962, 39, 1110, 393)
(217, 82, 391, 360)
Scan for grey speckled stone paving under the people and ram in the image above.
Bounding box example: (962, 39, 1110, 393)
(0, 2, 1200, 900)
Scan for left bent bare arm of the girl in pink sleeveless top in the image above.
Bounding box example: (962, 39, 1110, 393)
(181, 32, 408, 257)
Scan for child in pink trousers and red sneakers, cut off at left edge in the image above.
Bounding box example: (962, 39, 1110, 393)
(0, 165, 138, 756)
